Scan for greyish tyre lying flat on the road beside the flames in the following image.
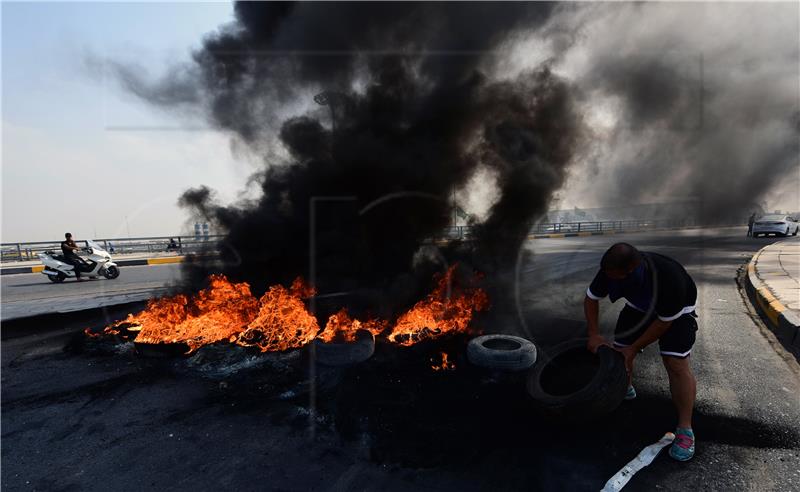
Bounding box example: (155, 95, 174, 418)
(467, 335, 536, 371)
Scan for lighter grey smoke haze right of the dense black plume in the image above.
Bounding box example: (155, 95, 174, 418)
(532, 2, 800, 219)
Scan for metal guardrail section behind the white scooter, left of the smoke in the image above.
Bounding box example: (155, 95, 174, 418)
(0, 235, 224, 263)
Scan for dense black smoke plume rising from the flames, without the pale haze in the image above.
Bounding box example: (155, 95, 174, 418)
(111, 2, 582, 310)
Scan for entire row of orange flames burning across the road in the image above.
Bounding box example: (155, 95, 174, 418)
(97, 265, 489, 353)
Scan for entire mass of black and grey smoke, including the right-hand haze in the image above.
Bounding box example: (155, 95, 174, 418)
(109, 2, 800, 316)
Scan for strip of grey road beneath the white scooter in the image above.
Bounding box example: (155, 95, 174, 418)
(0, 264, 180, 321)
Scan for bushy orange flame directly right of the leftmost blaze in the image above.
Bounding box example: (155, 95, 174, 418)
(233, 278, 319, 352)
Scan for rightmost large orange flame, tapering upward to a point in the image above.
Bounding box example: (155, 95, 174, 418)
(389, 265, 489, 345)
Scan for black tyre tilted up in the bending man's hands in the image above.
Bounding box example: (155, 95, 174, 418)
(528, 340, 628, 419)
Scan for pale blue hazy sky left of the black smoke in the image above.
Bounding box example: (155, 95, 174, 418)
(2, 2, 253, 242)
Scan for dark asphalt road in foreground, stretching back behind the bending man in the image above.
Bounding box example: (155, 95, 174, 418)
(2, 229, 800, 491)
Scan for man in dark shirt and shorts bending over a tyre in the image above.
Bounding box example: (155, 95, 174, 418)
(583, 243, 697, 461)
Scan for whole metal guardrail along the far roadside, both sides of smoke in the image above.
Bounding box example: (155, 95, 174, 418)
(0, 219, 697, 263)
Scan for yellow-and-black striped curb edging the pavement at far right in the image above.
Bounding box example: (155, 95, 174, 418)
(745, 245, 800, 352)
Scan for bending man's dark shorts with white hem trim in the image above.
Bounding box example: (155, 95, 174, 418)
(614, 305, 697, 359)
